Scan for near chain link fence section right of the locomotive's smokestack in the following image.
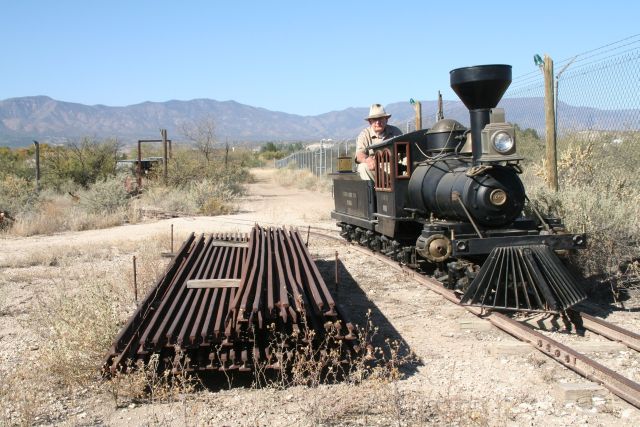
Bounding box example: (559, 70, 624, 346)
(500, 34, 640, 143)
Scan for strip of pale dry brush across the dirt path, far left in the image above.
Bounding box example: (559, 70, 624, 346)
(0, 177, 244, 236)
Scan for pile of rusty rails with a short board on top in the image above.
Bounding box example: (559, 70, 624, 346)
(104, 225, 356, 373)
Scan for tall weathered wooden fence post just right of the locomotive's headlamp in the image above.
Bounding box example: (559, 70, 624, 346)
(543, 55, 558, 191)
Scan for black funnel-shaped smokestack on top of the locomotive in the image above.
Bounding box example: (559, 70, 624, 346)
(449, 65, 511, 164)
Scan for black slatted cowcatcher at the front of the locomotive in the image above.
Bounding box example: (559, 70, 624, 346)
(460, 245, 587, 312)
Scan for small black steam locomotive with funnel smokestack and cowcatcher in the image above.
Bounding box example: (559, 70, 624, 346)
(331, 65, 586, 312)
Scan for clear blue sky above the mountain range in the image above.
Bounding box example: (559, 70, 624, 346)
(0, 0, 640, 115)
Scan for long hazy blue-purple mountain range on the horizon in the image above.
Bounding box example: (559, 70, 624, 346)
(0, 96, 639, 146)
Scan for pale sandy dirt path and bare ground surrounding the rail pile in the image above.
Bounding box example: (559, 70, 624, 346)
(0, 169, 640, 426)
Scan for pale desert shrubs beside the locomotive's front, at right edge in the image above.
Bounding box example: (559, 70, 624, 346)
(525, 139, 640, 294)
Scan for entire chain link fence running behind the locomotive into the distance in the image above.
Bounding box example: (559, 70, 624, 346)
(276, 34, 640, 175)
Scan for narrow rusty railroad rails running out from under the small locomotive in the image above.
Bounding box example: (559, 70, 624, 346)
(309, 230, 640, 408)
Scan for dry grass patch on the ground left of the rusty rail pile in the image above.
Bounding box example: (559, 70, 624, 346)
(0, 236, 175, 425)
